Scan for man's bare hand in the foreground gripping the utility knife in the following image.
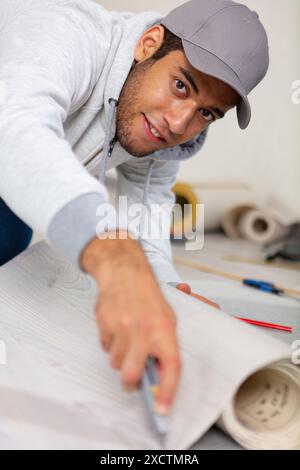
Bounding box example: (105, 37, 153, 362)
(80, 231, 181, 414)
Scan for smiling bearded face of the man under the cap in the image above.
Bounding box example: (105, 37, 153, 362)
(116, 51, 239, 157)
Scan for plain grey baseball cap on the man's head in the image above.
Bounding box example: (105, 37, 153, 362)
(160, 0, 269, 129)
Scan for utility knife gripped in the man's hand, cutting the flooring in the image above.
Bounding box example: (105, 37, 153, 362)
(142, 356, 169, 435)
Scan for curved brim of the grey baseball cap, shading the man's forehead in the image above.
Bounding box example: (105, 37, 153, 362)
(182, 39, 251, 129)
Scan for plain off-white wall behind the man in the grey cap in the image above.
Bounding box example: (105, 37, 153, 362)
(98, 0, 300, 228)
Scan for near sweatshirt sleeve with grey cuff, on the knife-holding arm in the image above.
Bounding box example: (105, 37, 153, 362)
(0, 4, 119, 261)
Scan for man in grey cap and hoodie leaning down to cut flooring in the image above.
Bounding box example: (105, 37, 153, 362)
(0, 0, 268, 414)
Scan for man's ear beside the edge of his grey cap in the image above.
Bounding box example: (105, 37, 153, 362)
(134, 24, 165, 62)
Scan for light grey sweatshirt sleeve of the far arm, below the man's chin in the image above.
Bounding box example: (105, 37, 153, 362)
(116, 157, 181, 282)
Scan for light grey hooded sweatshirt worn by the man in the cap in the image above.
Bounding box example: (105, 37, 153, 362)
(0, 0, 206, 282)
